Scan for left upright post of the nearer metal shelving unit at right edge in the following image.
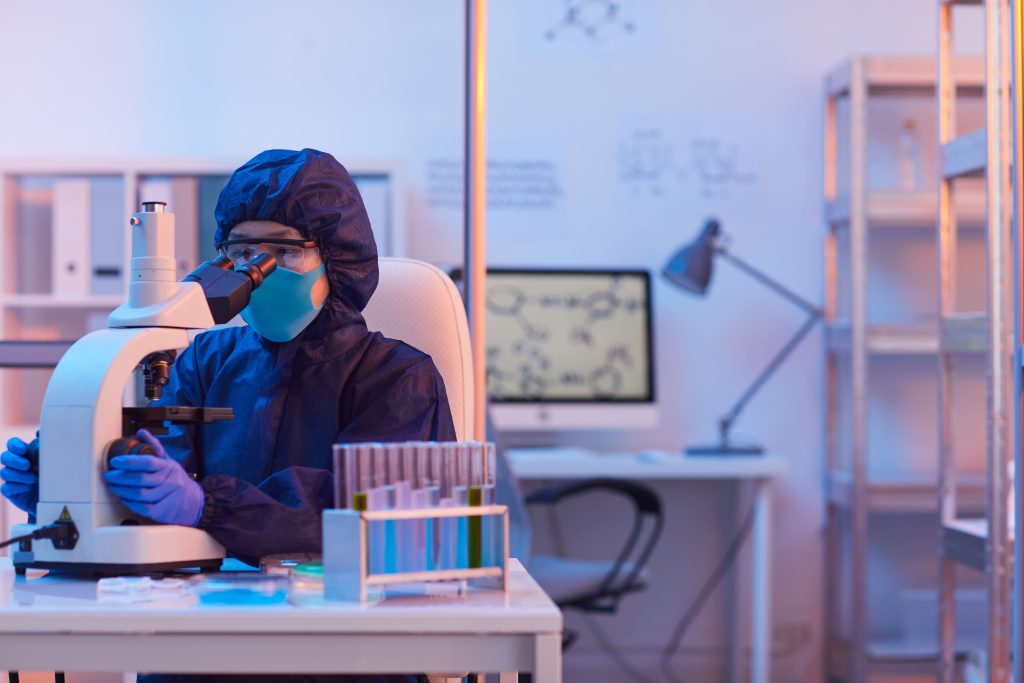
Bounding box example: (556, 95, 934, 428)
(935, 3, 956, 683)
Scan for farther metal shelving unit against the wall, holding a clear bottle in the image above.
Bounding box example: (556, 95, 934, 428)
(824, 56, 986, 683)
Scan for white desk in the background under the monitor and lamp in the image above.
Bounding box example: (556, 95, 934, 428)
(506, 449, 786, 683)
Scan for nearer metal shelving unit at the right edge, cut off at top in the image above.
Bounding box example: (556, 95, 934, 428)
(936, 0, 1014, 683)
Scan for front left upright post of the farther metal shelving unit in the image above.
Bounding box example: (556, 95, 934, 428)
(850, 59, 868, 683)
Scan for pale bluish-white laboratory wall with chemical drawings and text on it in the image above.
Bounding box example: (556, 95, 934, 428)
(0, 0, 981, 683)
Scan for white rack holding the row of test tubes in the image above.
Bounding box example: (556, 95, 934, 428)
(323, 505, 509, 602)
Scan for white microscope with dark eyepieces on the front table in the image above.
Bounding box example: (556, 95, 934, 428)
(12, 202, 276, 574)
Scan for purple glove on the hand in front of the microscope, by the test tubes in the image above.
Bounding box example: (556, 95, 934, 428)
(103, 429, 203, 526)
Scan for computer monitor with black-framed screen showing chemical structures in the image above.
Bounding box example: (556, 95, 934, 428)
(486, 268, 657, 431)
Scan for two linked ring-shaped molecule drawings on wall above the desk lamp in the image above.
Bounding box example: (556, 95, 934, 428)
(618, 127, 757, 200)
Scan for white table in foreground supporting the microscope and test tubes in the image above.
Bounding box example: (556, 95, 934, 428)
(0, 560, 562, 683)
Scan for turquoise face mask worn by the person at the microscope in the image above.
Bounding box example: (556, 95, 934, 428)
(242, 263, 327, 342)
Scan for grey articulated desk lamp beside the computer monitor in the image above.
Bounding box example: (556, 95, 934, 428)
(662, 218, 822, 456)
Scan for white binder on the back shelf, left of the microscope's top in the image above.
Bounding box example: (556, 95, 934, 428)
(50, 178, 92, 299)
